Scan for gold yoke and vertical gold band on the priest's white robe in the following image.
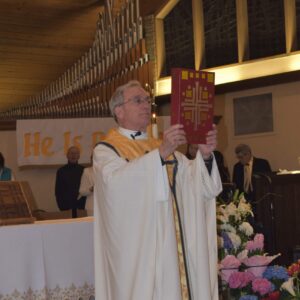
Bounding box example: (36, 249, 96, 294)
(104, 128, 190, 300)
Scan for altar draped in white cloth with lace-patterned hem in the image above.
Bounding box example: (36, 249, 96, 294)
(0, 217, 95, 300)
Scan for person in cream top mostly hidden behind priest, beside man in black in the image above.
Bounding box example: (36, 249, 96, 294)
(78, 156, 94, 216)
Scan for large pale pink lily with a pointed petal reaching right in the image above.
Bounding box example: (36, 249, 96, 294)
(242, 254, 280, 277)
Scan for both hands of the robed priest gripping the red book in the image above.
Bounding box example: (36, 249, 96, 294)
(159, 124, 217, 160)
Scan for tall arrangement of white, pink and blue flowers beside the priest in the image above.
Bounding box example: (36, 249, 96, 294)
(217, 191, 288, 300)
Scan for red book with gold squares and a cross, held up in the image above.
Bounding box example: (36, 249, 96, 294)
(171, 68, 215, 144)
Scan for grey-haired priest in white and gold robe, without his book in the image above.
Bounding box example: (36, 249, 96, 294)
(94, 81, 222, 300)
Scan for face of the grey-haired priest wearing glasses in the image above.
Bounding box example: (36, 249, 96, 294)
(115, 86, 151, 132)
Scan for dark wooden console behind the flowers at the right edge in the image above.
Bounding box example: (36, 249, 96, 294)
(255, 174, 300, 265)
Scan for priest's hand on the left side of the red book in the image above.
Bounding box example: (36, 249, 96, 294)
(158, 124, 186, 160)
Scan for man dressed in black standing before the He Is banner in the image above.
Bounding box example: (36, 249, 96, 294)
(55, 146, 86, 218)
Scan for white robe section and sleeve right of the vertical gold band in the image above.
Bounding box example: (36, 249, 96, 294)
(173, 152, 222, 300)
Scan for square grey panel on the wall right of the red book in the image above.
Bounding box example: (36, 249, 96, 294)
(233, 93, 274, 136)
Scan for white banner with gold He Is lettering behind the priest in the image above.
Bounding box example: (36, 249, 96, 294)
(17, 117, 170, 166)
